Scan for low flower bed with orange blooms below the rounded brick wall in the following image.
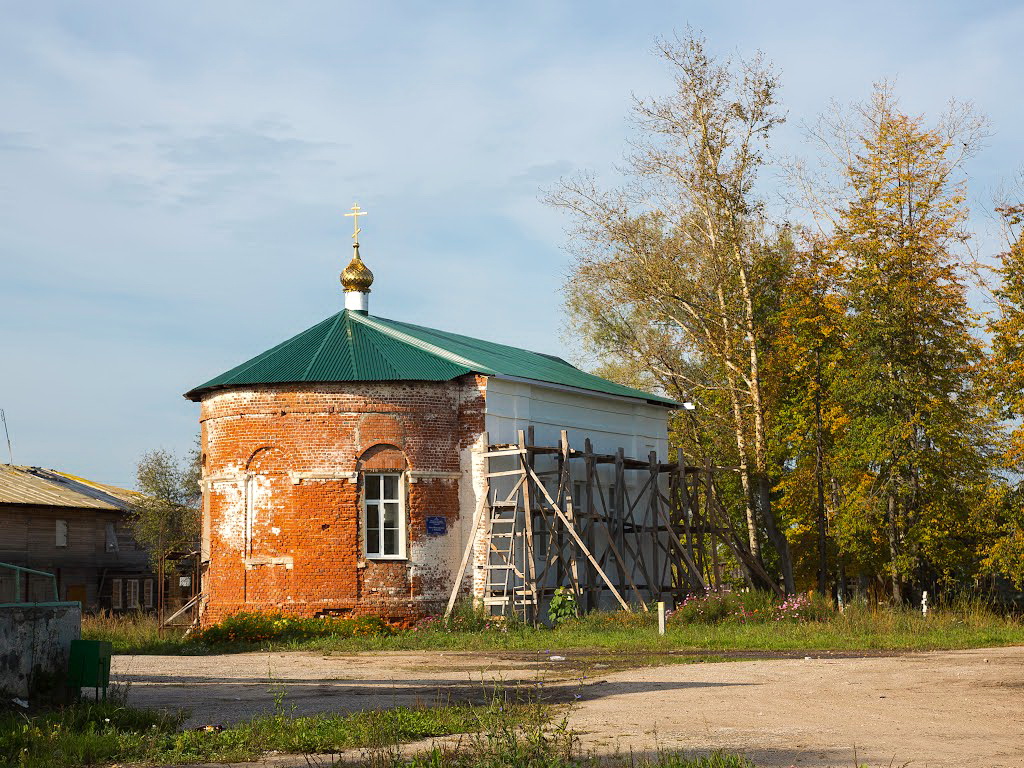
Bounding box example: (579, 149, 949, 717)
(197, 612, 393, 645)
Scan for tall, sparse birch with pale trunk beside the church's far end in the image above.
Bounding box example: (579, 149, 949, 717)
(549, 32, 794, 592)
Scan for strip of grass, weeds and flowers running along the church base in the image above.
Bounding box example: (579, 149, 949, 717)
(82, 593, 1024, 654)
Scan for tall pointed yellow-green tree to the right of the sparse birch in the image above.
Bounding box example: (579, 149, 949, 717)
(830, 85, 994, 602)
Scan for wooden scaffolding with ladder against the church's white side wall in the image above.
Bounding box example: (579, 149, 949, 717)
(446, 427, 777, 624)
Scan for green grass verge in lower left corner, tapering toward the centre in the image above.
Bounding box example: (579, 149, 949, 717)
(0, 698, 536, 768)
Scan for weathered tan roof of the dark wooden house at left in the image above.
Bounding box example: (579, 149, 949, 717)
(0, 464, 135, 511)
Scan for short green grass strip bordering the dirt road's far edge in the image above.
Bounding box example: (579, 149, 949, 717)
(82, 600, 1024, 654)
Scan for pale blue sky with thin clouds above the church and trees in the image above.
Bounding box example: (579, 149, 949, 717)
(0, 0, 1024, 485)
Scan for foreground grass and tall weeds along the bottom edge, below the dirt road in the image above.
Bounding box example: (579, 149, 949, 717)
(0, 697, 770, 768)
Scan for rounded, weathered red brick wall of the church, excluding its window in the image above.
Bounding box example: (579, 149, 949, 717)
(201, 376, 483, 625)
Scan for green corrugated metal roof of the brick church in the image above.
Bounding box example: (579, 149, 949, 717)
(185, 309, 679, 406)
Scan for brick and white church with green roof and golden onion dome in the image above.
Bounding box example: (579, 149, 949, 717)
(185, 206, 679, 625)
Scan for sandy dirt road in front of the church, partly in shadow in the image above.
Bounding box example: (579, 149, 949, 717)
(114, 647, 1024, 768)
